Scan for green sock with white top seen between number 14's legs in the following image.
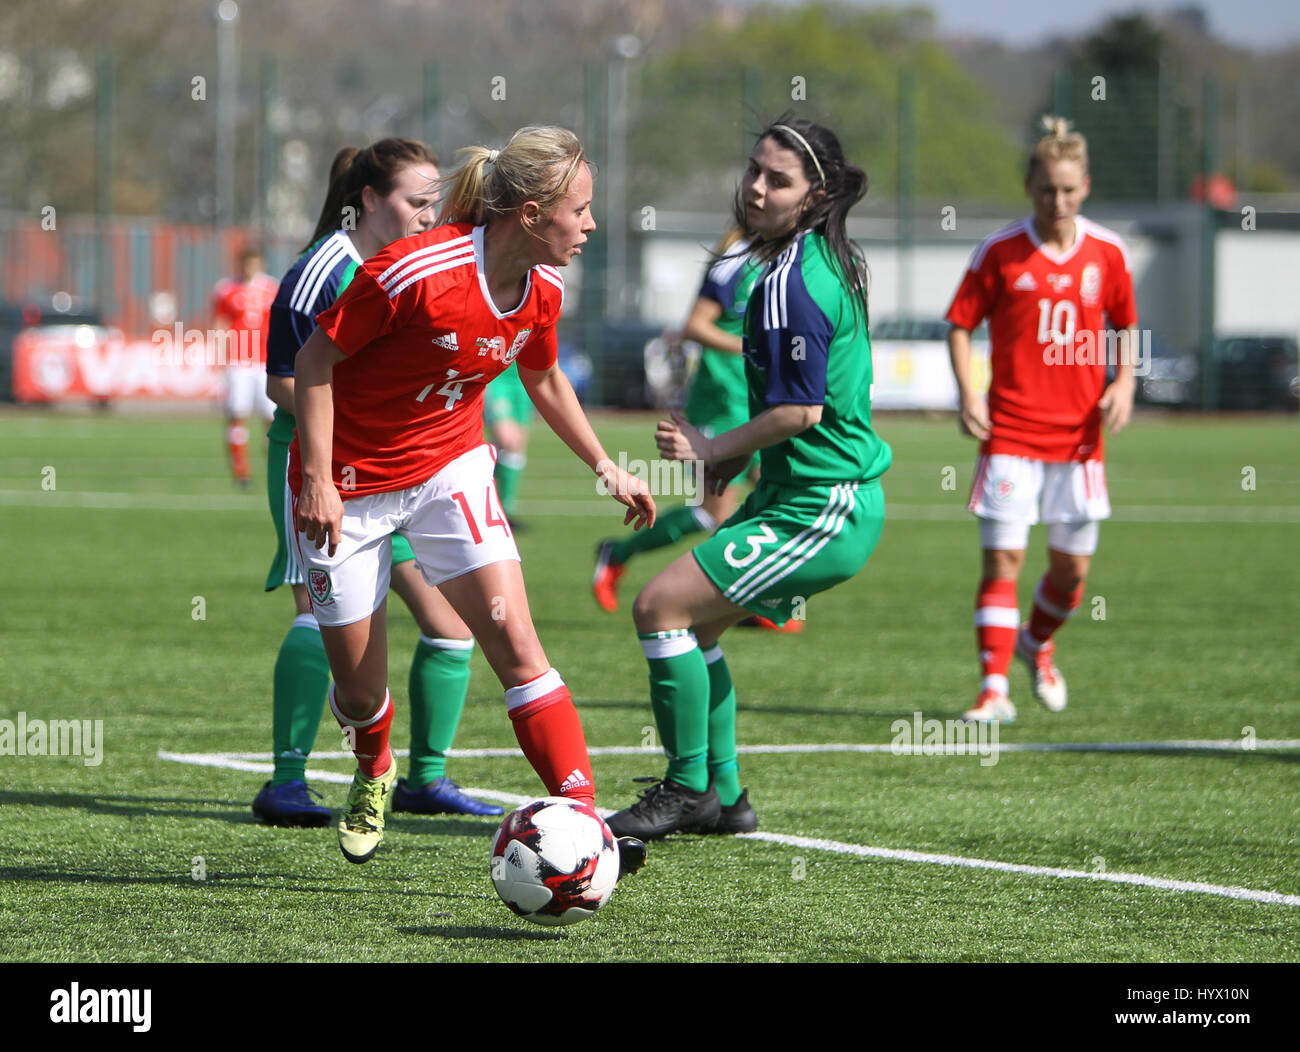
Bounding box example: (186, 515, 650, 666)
(407, 636, 475, 789)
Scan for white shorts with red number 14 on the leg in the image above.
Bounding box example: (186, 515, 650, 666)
(294, 443, 519, 627)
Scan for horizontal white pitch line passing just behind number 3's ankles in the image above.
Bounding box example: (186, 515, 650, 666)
(192, 737, 1300, 759)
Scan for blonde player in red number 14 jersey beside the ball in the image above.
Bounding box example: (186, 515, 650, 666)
(290, 127, 655, 869)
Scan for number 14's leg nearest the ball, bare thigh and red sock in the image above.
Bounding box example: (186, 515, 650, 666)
(438, 559, 595, 804)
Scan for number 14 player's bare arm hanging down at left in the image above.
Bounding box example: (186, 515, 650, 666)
(294, 329, 343, 555)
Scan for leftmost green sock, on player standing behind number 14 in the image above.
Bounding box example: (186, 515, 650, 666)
(270, 614, 329, 785)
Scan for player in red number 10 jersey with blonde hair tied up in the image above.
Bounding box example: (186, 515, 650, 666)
(948, 117, 1138, 722)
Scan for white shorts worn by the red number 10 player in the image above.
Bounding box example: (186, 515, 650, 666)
(966, 453, 1110, 555)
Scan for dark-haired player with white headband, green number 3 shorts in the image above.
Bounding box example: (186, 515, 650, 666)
(608, 117, 892, 840)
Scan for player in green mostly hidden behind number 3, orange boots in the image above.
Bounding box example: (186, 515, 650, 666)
(592, 226, 763, 614)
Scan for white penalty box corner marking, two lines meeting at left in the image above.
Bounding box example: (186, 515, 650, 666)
(159, 739, 1300, 906)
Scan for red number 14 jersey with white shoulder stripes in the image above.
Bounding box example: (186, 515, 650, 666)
(289, 222, 564, 499)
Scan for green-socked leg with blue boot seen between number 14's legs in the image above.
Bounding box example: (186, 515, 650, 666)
(391, 559, 503, 815)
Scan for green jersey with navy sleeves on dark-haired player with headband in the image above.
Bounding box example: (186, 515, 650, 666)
(745, 231, 893, 486)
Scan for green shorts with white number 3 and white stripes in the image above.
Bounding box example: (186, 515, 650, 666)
(694, 479, 885, 624)
